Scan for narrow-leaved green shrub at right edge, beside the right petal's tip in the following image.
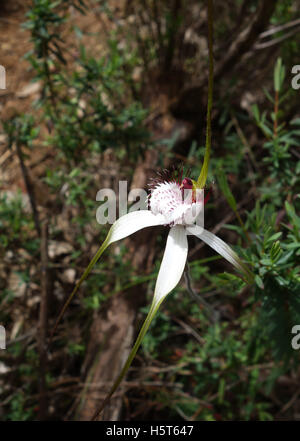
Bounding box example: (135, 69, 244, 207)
(243, 203, 300, 360)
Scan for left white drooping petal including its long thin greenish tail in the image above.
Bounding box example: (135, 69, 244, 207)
(50, 210, 165, 341)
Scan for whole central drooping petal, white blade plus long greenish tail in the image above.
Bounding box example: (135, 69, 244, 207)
(93, 225, 188, 419)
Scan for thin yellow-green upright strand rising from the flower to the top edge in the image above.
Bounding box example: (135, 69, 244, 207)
(197, 0, 214, 188)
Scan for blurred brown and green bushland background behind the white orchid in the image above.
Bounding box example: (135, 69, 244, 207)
(0, 0, 300, 421)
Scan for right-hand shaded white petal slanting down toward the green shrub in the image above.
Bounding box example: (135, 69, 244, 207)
(187, 225, 253, 283)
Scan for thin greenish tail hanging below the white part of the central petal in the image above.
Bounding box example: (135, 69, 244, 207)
(92, 299, 164, 421)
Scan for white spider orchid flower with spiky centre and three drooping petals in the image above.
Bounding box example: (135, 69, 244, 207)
(53, 173, 251, 414)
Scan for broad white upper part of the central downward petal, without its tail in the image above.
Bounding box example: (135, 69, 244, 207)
(154, 225, 188, 303)
